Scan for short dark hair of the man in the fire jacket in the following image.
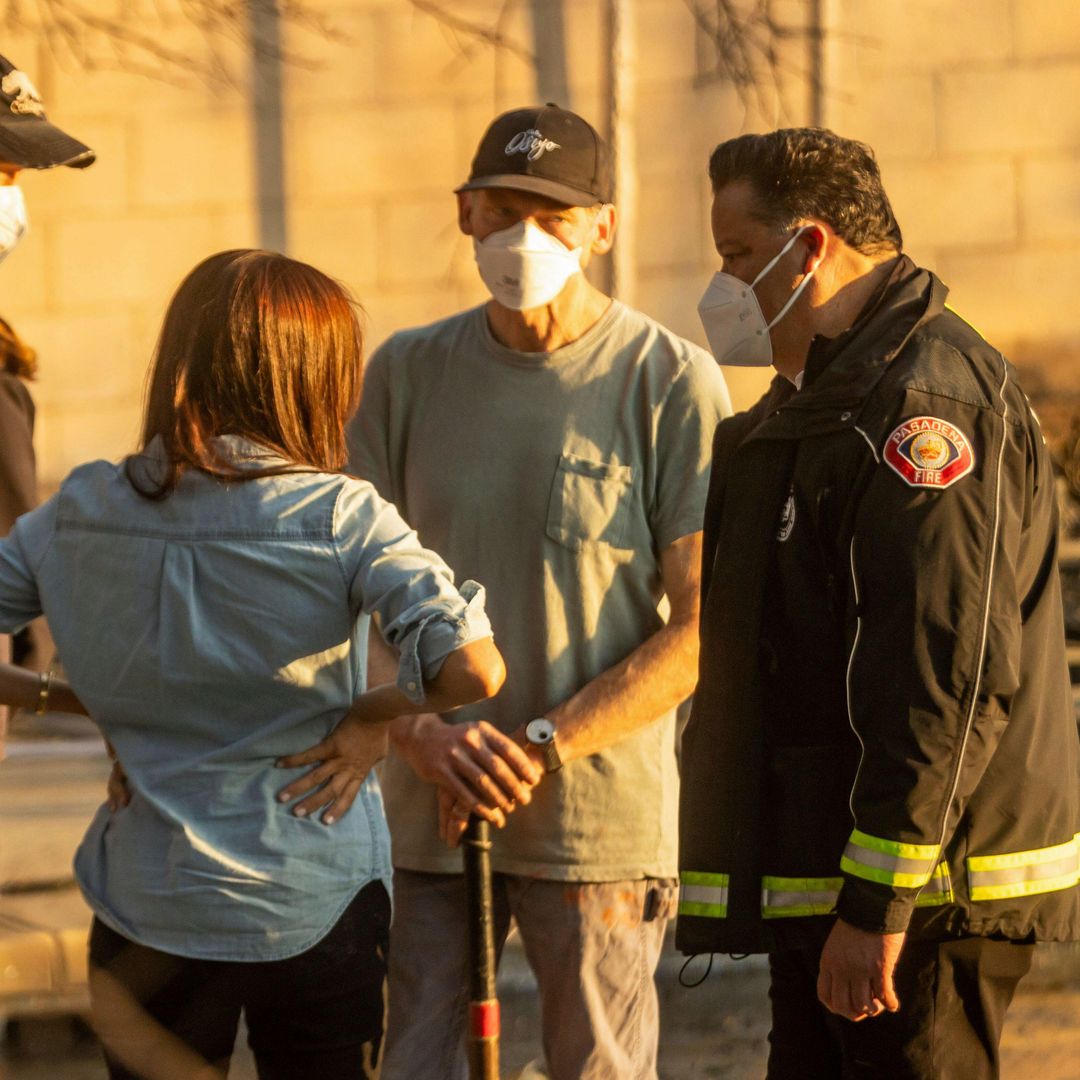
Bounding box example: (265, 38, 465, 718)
(708, 127, 904, 255)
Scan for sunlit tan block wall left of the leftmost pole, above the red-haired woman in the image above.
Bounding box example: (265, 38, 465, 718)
(0, 17, 255, 491)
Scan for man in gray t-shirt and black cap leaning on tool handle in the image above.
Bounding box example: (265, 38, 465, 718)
(350, 106, 730, 1080)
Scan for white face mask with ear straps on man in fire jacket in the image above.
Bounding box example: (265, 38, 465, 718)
(698, 225, 818, 367)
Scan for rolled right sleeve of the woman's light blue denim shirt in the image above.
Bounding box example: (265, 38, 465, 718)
(335, 482, 491, 704)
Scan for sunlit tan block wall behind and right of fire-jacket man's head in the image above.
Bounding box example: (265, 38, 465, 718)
(825, 0, 1080, 396)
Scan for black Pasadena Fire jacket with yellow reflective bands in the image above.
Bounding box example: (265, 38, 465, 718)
(677, 258, 1080, 954)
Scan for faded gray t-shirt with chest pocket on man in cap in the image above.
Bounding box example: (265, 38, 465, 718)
(350, 301, 731, 881)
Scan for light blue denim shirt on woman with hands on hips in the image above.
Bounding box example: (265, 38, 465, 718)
(0, 436, 490, 960)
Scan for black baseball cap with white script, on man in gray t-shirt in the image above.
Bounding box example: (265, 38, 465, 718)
(456, 102, 612, 206)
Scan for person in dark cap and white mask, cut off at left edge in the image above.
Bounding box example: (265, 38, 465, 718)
(0, 56, 94, 759)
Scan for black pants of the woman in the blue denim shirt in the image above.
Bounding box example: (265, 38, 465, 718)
(90, 881, 390, 1080)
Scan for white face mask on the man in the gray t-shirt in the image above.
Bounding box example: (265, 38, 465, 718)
(473, 221, 581, 311)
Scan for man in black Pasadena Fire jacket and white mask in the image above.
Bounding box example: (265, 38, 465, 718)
(678, 129, 1080, 1080)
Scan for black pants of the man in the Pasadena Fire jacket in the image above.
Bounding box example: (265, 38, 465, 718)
(767, 937, 1035, 1080)
